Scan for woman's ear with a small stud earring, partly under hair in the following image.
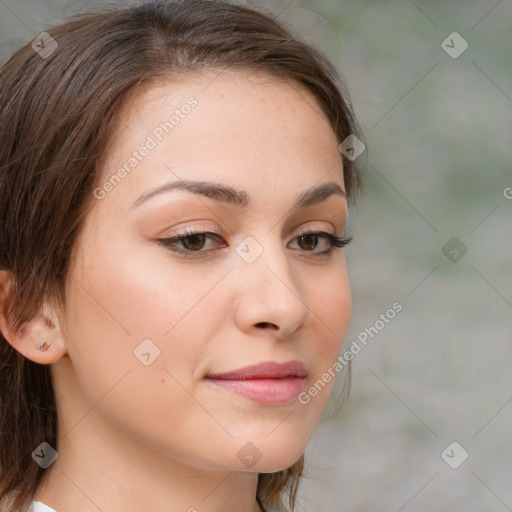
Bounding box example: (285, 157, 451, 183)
(0, 270, 66, 364)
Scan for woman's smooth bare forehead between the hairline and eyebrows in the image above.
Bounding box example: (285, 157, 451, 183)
(95, 71, 343, 210)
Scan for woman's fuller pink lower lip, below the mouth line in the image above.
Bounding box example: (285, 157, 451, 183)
(207, 377, 305, 404)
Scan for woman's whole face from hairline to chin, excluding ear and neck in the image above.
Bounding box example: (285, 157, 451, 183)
(53, 73, 351, 472)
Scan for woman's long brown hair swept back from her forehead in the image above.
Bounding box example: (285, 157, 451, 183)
(0, 0, 361, 510)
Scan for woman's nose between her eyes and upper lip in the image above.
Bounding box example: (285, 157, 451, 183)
(233, 237, 310, 339)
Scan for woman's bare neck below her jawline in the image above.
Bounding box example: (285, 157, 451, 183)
(34, 419, 262, 512)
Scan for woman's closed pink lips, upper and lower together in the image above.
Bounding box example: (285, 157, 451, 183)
(206, 361, 306, 405)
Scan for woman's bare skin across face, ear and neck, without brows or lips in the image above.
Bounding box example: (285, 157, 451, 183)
(0, 72, 351, 512)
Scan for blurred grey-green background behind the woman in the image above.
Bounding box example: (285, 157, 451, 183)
(0, 0, 512, 512)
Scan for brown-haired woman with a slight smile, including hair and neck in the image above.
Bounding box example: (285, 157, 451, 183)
(0, 0, 360, 512)
